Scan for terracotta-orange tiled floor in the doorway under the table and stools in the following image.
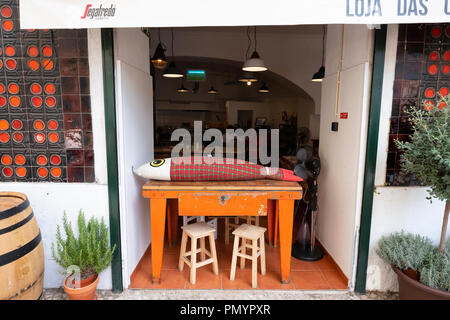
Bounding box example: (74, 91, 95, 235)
(130, 236, 348, 290)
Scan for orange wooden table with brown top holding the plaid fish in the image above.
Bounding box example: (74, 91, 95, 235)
(142, 180, 302, 283)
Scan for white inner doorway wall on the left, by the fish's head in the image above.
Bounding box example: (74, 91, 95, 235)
(114, 29, 153, 288)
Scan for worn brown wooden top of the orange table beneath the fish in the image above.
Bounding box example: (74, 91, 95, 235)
(142, 179, 303, 192)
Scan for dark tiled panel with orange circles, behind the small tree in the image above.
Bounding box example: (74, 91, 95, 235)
(386, 24, 450, 186)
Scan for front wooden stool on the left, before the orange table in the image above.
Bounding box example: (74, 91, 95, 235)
(178, 222, 219, 284)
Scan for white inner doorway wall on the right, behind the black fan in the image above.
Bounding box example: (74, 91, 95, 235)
(317, 25, 373, 287)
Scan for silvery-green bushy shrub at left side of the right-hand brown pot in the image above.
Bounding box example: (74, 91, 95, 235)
(376, 231, 433, 271)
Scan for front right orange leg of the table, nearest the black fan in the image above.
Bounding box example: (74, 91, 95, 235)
(277, 200, 294, 283)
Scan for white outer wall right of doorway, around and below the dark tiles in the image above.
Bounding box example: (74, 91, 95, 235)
(366, 25, 450, 291)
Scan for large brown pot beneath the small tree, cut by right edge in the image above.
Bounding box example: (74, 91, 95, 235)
(392, 266, 450, 300)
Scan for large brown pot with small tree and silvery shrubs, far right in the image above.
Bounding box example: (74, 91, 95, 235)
(377, 95, 450, 300)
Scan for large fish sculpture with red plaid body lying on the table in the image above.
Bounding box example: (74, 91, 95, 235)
(133, 157, 303, 181)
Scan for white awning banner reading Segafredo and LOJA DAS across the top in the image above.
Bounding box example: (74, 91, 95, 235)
(20, 0, 450, 29)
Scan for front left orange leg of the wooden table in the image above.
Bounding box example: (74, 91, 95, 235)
(150, 199, 166, 283)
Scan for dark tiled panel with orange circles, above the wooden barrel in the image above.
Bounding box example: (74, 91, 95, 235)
(0, 1, 95, 182)
